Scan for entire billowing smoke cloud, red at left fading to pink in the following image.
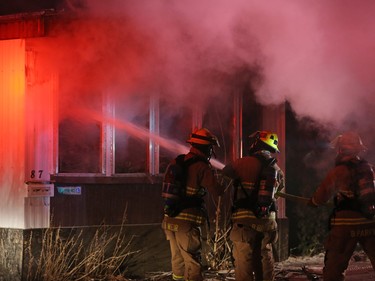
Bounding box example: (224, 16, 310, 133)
(49, 0, 375, 147)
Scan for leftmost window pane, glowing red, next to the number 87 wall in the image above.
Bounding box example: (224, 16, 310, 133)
(58, 91, 103, 174)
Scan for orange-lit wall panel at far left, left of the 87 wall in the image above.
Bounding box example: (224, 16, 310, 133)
(0, 39, 26, 228)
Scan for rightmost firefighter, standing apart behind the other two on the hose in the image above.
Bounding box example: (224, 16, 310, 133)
(309, 132, 375, 281)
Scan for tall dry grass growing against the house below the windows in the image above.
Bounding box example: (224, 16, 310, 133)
(25, 214, 137, 281)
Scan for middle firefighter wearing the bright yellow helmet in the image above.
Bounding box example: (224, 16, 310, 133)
(223, 131, 285, 281)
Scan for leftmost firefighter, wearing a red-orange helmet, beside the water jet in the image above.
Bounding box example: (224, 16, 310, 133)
(162, 128, 224, 281)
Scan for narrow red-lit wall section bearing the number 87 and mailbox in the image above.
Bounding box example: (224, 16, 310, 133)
(25, 38, 58, 228)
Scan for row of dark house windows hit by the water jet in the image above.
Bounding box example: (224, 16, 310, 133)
(58, 89, 247, 176)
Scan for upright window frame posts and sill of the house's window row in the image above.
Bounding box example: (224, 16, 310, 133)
(53, 93, 243, 179)
